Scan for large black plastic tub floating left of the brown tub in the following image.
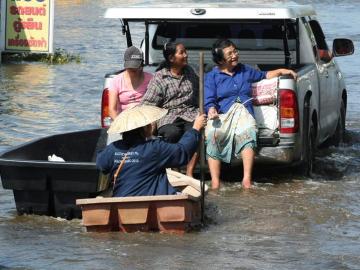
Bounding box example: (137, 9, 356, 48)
(0, 129, 108, 219)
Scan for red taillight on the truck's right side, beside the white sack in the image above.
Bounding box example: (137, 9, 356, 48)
(280, 89, 299, 133)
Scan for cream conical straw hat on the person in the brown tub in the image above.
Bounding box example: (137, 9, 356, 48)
(107, 105, 168, 134)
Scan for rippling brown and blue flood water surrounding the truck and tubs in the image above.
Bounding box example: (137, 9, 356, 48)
(0, 0, 360, 269)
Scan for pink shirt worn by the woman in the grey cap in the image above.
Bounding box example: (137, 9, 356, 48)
(109, 72, 153, 113)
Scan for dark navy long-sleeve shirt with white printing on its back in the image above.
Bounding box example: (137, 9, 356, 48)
(96, 129, 200, 197)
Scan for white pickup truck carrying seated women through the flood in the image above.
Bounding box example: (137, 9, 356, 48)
(101, 4, 354, 175)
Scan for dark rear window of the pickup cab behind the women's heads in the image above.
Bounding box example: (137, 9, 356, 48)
(152, 20, 296, 51)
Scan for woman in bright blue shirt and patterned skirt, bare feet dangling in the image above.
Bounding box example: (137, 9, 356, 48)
(204, 39, 297, 189)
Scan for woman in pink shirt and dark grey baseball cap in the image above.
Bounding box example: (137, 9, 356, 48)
(109, 46, 152, 120)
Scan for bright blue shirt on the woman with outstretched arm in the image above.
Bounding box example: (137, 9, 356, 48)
(204, 64, 266, 116)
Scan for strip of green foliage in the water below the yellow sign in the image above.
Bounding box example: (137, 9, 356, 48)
(3, 48, 81, 64)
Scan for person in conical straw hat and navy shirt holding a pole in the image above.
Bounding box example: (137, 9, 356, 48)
(96, 105, 207, 197)
